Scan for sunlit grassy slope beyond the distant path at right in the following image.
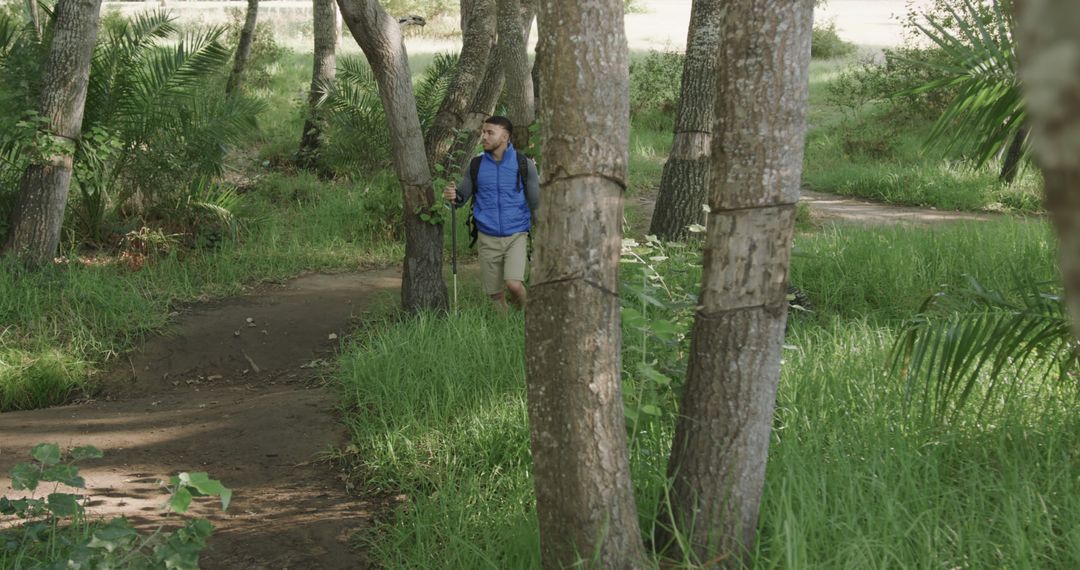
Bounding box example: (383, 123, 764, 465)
(802, 59, 1042, 213)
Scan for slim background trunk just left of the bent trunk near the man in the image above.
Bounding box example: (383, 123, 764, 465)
(297, 0, 337, 168)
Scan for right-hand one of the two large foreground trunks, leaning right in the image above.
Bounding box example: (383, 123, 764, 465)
(657, 0, 813, 568)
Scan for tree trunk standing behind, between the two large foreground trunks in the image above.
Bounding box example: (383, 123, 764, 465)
(649, 0, 726, 241)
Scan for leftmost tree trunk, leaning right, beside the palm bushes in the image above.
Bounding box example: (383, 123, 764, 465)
(3, 0, 102, 266)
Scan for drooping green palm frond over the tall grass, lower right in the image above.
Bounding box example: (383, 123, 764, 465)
(890, 279, 1080, 423)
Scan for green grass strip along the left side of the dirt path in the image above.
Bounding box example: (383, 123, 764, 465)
(0, 175, 403, 410)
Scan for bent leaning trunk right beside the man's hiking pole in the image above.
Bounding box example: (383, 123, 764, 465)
(338, 0, 448, 311)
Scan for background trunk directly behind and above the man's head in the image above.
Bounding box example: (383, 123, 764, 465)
(496, 0, 536, 151)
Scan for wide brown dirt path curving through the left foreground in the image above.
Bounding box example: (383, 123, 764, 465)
(0, 270, 401, 569)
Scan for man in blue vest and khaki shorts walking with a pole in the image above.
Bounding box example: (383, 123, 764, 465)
(443, 117, 540, 311)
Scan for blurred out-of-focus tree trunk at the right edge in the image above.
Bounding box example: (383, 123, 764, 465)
(1016, 0, 1080, 338)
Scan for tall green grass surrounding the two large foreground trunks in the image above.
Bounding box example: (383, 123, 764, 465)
(339, 215, 1080, 569)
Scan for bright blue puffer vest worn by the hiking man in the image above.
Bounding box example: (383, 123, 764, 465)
(473, 145, 531, 238)
